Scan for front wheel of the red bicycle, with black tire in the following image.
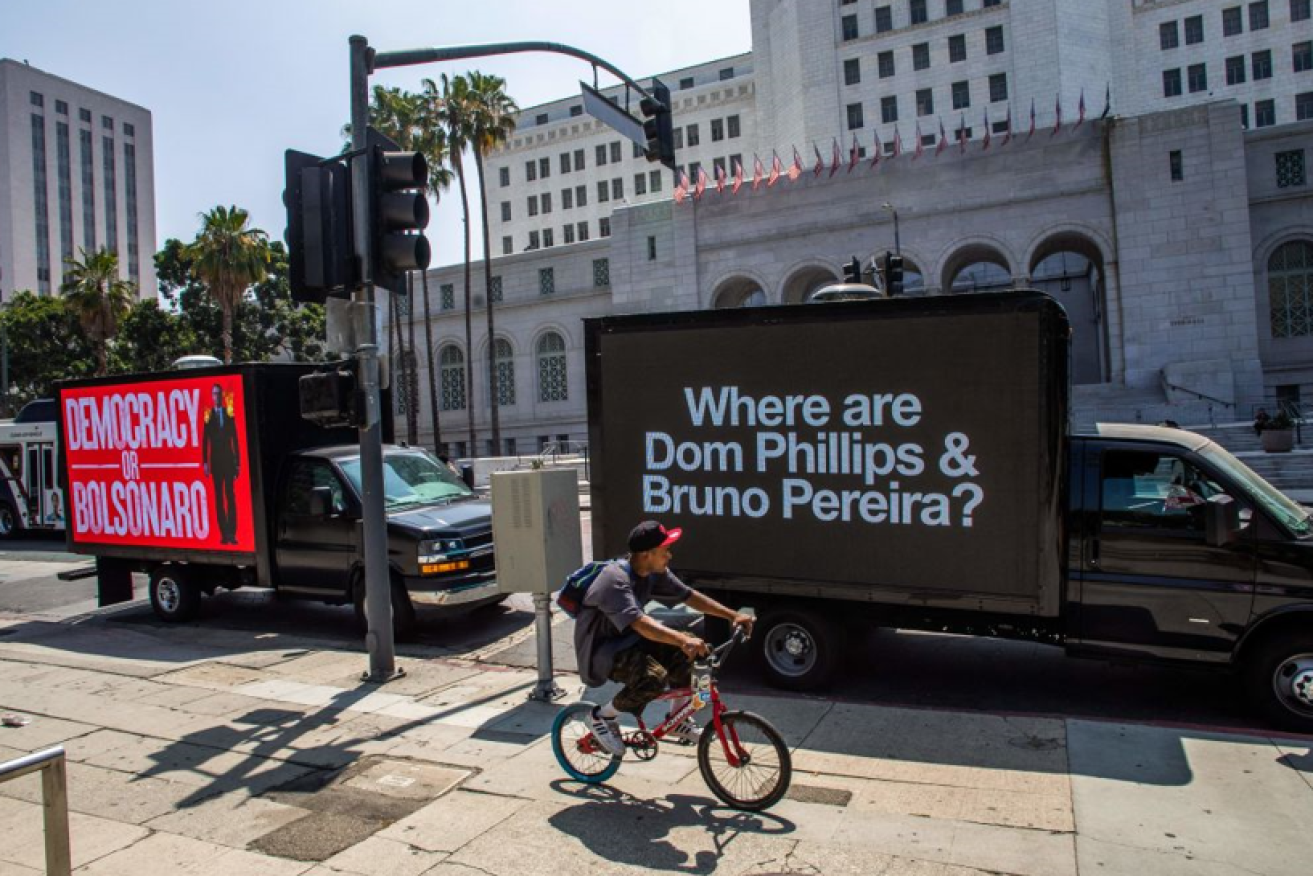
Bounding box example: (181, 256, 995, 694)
(697, 712, 793, 812)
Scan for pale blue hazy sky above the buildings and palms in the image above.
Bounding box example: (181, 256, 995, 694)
(0, 0, 751, 286)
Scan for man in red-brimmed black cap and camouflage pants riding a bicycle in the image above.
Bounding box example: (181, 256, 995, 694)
(575, 520, 752, 755)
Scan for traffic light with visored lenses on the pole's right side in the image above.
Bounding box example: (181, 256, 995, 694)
(368, 127, 431, 294)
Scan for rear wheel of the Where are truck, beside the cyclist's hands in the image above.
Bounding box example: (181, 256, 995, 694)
(752, 609, 842, 691)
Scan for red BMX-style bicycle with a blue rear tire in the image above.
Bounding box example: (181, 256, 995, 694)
(551, 629, 793, 812)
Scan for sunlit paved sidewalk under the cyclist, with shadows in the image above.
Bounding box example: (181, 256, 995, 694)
(0, 609, 1313, 876)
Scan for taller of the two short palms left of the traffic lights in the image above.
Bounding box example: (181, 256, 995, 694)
(185, 206, 269, 365)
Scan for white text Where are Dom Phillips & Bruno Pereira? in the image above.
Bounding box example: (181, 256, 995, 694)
(642, 386, 985, 527)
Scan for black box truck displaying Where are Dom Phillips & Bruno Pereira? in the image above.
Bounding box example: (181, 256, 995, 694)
(586, 290, 1313, 730)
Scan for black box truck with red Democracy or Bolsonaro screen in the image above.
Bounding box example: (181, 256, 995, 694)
(56, 364, 502, 636)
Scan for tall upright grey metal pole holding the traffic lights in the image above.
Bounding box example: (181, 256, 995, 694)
(351, 35, 397, 684)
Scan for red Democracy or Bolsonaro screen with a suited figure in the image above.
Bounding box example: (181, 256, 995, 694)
(59, 374, 255, 553)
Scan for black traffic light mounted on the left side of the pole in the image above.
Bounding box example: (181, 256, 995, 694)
(282, 150, 356, 305)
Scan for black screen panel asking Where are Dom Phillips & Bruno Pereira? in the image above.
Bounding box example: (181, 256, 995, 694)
(590, 297, 1065, 600)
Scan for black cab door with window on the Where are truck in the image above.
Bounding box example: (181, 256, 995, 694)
(1079, 441, 1257, 661)
